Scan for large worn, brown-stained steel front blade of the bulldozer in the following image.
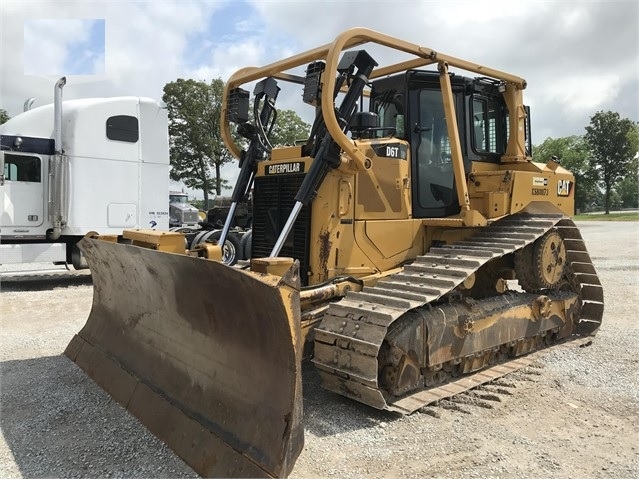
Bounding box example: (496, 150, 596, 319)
(64, 238, 304, 477)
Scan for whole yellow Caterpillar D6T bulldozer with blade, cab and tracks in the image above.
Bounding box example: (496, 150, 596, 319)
(65, 28, 603, 477)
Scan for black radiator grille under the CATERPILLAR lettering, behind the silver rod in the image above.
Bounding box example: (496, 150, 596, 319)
(251, 174, 311, 286)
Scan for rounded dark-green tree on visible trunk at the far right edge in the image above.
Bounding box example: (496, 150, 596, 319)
(585, 111, 639, 214)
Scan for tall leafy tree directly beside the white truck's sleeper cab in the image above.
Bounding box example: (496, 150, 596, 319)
(162, 78, 232, 204)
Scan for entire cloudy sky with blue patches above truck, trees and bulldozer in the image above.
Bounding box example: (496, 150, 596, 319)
(0, 0, 639, 195)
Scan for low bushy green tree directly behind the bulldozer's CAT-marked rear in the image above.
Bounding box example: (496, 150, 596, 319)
(533, 135, 603, 212)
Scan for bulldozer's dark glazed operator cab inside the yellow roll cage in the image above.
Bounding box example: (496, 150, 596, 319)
(362, 70, 530, 218)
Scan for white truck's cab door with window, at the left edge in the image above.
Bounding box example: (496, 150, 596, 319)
(0, 152, 45, 229)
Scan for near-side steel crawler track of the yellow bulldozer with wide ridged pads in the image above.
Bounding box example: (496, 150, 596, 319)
(313, 213, 603, 414)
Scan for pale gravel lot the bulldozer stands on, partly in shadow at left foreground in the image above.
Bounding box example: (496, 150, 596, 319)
(0, 222, 639, 479)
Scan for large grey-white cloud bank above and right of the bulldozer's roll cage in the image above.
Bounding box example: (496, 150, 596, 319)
(248, 0, 639, 143)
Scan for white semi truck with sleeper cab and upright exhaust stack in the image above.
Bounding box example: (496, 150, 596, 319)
(0, 78, 169, 269)
